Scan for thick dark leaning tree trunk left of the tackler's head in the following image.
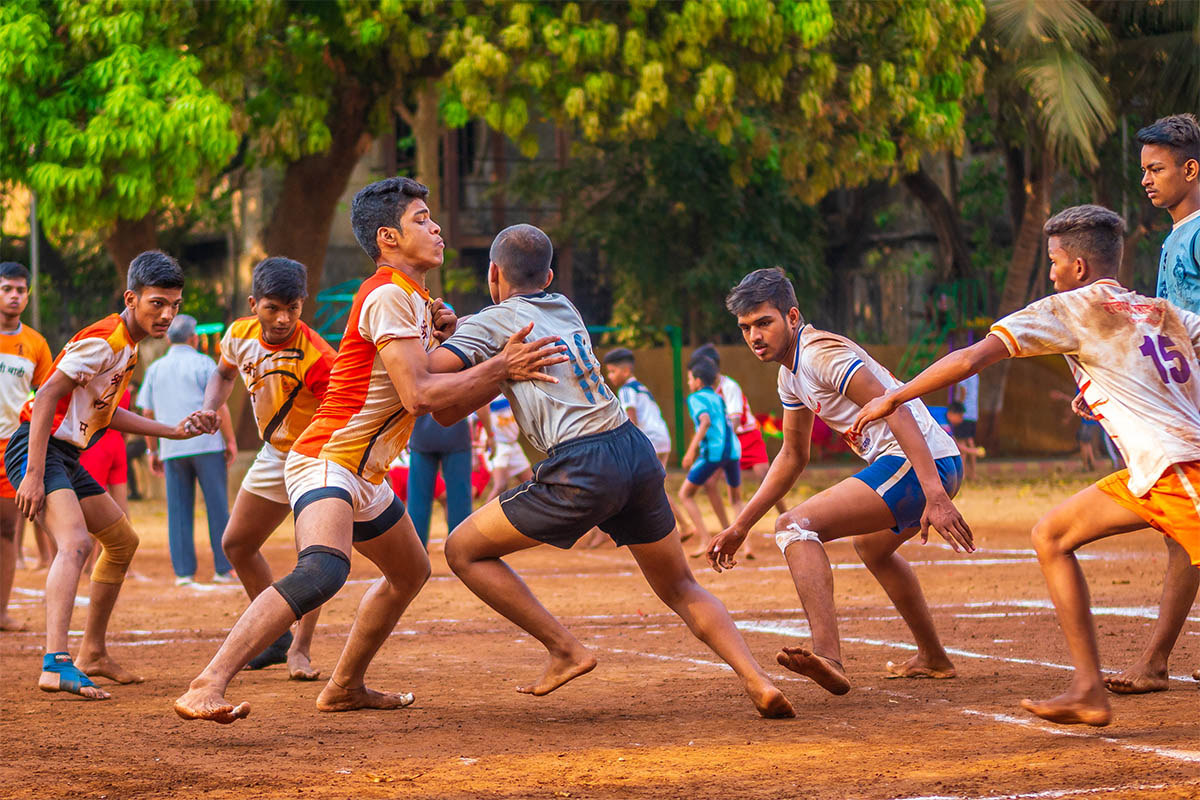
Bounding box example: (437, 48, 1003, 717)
(263, 84, 372, 311)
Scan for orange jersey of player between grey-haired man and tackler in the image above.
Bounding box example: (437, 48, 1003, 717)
(221, 317, 336, 452)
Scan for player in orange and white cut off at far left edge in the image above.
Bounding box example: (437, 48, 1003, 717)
(0, 261, 54, 631)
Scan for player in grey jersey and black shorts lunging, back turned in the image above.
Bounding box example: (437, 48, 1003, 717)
(431, 224, 794, 717)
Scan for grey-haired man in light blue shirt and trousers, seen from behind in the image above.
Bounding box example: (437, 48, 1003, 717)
(137, 314, 238, 585)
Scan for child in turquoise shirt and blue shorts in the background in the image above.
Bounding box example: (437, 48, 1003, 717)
(679, 359, 745, 558)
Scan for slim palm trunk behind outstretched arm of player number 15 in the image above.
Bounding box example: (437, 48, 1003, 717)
(979, 151, 1055, 447)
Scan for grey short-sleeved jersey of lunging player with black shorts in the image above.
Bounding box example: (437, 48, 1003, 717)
(443, 291, 629, 452)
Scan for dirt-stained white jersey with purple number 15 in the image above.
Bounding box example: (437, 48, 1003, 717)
(989, 278, 1200, 497)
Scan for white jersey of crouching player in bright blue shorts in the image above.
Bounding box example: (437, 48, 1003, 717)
(779, 325, 959, 464)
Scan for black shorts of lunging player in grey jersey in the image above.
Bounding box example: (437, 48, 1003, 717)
(500, 422, 674, 549)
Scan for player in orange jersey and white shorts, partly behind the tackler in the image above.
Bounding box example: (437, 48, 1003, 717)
(204, 257, 335, 680)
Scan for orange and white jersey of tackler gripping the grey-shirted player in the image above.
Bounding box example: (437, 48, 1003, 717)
(292, 265, 437, 483)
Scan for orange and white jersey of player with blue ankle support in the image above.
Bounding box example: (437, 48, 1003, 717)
(20, 314, 138, 450)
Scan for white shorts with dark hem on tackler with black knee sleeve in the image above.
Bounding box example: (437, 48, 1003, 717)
(283, 450, 404, 542)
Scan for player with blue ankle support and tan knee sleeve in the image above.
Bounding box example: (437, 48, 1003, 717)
(12, 251, 208, 700)
